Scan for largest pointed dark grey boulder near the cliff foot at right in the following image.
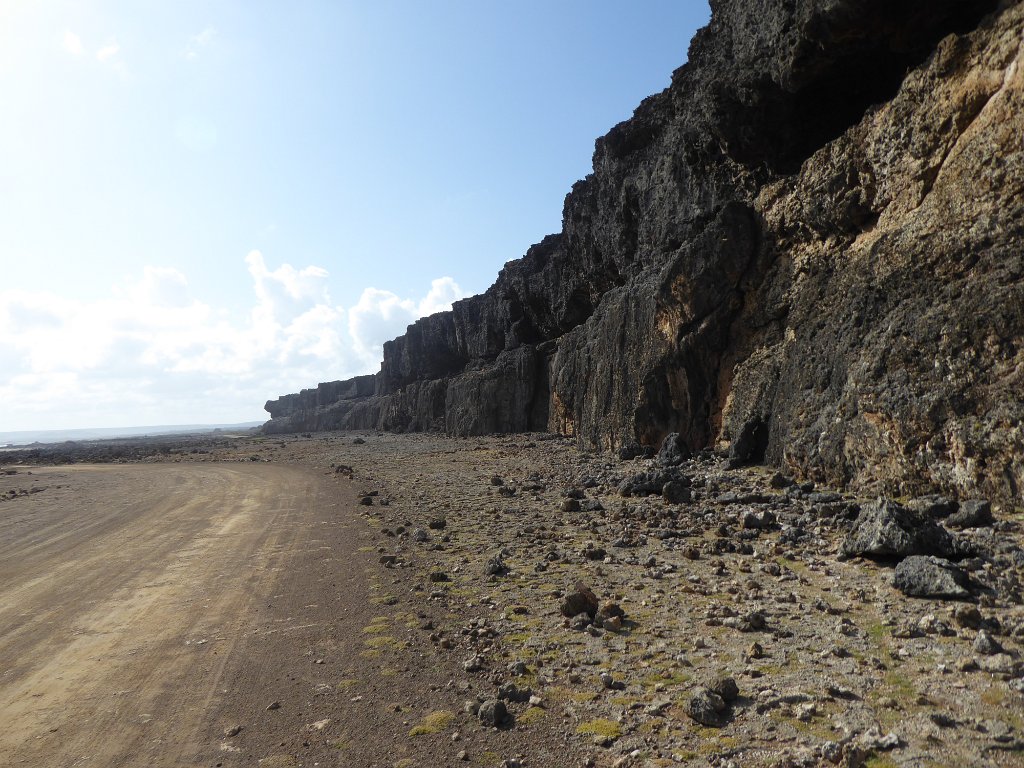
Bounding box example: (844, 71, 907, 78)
(841, 499, 956, 558)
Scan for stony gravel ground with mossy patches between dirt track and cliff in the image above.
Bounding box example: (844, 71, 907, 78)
(2, 432, 1024, 766)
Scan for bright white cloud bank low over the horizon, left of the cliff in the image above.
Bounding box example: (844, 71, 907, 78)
(0, 251, 463, 431)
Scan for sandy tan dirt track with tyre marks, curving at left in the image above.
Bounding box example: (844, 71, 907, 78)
(0, 464, 337, 766)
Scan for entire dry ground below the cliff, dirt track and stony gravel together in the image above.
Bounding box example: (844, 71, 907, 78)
(0, 433, 1024, 768)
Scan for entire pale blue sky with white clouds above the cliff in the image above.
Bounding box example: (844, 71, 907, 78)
(0, 0, 709, 431)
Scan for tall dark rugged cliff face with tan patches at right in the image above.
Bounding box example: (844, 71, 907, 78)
(265, 0, 1024, 512)
